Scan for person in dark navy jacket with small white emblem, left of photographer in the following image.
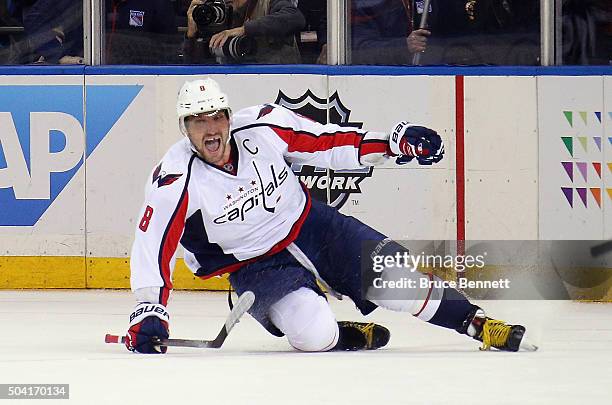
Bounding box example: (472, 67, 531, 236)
(105, 0, 180, 64)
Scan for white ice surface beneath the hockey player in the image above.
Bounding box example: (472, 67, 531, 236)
(0, 290, 612, 405)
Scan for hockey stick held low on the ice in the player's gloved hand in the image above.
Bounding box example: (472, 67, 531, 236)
(104, 291, 255, 349)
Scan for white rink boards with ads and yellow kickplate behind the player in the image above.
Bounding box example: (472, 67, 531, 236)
(0, 68, 612, 300)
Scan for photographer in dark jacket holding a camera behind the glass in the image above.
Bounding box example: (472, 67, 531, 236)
(184, 0, 304, 64)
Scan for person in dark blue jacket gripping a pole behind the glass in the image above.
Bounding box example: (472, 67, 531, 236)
(317, 0, 431, 65)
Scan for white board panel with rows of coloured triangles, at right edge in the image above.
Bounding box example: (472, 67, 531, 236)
(538, 76, 612, 239)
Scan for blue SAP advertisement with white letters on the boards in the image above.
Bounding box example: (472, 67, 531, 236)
(0, 85, 141, 226)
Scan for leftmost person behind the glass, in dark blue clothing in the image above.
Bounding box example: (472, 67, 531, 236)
(19, 0, 83, 64)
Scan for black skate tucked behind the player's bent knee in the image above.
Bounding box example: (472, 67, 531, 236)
(334, 321, 391, 350)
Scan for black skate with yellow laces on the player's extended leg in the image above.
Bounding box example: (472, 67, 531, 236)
(457, 306, 537, 352)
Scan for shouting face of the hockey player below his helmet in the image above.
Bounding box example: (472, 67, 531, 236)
(185, 111, 230, 165)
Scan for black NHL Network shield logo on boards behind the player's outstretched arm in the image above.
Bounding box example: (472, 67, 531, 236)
(274, 89, 374, 209)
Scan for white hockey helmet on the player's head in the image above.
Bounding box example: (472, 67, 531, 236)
(176, 78, 232, 136)
